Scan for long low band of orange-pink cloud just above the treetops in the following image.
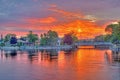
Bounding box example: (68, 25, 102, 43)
(0, 20, 105, 39)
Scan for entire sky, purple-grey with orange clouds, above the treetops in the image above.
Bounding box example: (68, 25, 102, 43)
(0, 0, 120, 38)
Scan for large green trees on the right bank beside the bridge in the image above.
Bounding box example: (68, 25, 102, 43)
(95, 22, 120, 43)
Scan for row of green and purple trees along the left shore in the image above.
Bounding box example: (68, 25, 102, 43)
(0, 30, 78, 46)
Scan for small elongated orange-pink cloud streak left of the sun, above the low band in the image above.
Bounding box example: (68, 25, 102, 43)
(26, 17, 57, 24)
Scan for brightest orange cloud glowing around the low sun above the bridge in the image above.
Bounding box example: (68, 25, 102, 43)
(51, 20, 105, 39)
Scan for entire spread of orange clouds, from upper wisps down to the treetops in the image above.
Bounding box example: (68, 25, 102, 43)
(0, 4, 105, 39)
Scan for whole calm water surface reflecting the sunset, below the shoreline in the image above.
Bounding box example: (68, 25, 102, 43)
(0, 49, 120, 80)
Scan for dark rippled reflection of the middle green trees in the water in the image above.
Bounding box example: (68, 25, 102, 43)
(27, 50, 58, 62)
